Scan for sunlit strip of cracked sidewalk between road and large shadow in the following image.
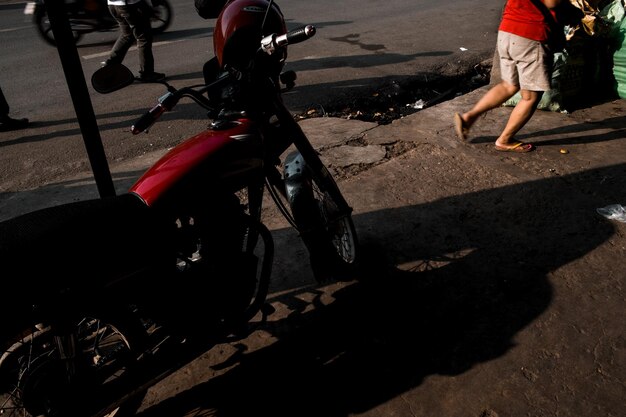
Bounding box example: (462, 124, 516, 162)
(0, 86, 626, 220)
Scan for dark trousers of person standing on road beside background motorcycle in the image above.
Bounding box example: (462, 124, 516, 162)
(109, 1, 154, 74)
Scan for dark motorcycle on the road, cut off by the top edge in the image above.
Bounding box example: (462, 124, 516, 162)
(24, 0, 174, 46)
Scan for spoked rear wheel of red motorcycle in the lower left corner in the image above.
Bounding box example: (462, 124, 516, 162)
(0, 317, 145, 417)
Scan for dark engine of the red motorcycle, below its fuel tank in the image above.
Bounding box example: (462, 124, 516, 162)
(142, 195, 264, 334)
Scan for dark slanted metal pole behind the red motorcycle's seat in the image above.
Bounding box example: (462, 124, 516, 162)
(44, 0, 115, 197)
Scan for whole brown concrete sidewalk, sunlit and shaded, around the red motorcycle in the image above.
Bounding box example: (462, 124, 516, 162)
(0, 87, 626, 417)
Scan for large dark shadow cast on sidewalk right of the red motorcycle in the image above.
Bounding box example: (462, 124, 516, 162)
(133, 165, 626, 417)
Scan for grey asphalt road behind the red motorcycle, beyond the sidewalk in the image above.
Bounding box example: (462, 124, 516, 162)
(0, 0, 503, 193)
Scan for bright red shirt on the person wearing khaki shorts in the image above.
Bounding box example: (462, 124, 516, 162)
(499, 0, 550, 42)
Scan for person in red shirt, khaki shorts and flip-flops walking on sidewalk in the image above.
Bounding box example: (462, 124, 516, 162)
(454, 0, 561, 152)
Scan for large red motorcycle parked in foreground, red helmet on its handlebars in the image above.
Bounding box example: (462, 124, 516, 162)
(0, 0, 359, 417)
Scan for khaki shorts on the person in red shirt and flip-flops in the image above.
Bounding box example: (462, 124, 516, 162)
(498, 31, 552, 91)
